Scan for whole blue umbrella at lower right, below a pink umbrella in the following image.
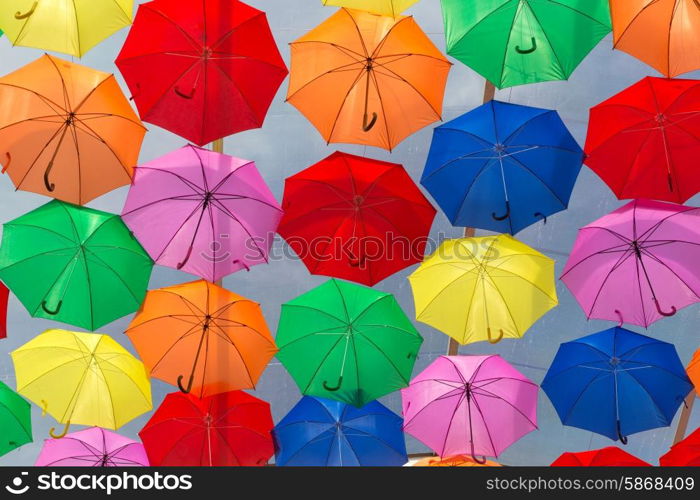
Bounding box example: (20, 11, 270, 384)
(542, 327, 693, 444)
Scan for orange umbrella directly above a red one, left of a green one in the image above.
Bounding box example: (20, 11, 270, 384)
(126, 280, 277, 398)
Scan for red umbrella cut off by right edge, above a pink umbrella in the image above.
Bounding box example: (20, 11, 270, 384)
(585, 77, 700, 203)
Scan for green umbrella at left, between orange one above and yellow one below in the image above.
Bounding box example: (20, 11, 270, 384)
(0, 200, 153, 330)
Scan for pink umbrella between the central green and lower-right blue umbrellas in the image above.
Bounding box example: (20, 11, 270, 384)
(401, 355, 539, 463)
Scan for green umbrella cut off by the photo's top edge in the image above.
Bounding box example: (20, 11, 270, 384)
(442, 0, 612, 88)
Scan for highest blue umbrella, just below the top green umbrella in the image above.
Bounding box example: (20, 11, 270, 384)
(421, 101, 584, 234)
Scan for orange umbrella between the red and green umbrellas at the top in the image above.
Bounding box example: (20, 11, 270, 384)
(287, 9, 450, 150)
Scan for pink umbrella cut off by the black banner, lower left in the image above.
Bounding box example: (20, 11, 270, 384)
(34, 427, 148, 467)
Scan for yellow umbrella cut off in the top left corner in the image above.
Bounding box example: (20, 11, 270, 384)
(0, 0, 134, 57)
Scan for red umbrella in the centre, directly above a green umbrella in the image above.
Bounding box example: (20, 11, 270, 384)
(279, 152, 435, 286)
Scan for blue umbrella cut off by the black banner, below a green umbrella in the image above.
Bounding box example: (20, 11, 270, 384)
(273, 396, 408, 467)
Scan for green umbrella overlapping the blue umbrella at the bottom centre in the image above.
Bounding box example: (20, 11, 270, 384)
(275, 279, 423, 406)
